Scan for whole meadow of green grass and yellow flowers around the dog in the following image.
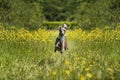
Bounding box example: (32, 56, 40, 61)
(0, 28, 120, 80)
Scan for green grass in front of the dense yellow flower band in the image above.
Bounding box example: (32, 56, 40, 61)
(0, 35, 120, 80)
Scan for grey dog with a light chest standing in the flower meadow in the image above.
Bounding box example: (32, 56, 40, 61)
(55, 26, 68, 53)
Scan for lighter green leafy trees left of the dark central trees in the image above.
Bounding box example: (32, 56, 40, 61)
(0, 0, 43, 29)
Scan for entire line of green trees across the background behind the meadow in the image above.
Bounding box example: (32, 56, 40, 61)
(0, 0, 120, 29)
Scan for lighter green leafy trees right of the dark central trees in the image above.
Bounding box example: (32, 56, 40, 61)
(76, 0, 120, 29)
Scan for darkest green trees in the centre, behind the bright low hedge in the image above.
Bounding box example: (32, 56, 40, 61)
(43, 0, 76, 21)
